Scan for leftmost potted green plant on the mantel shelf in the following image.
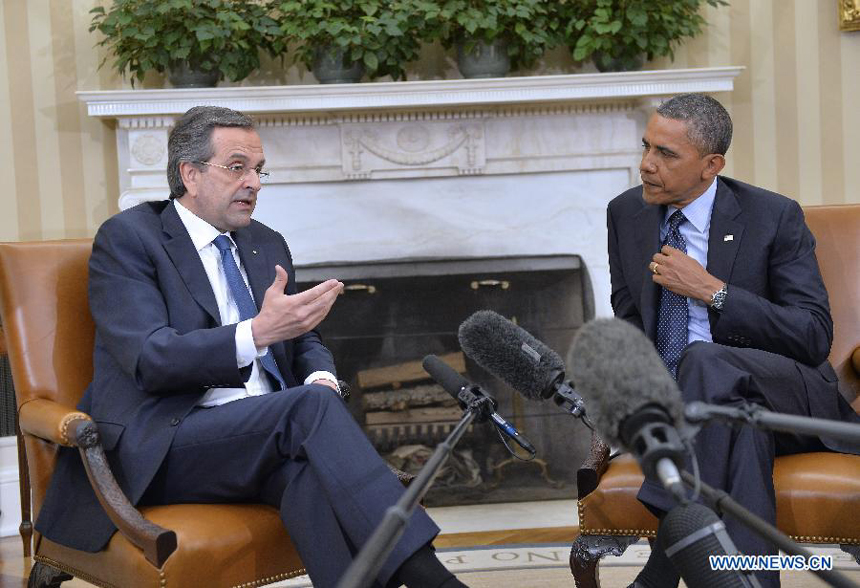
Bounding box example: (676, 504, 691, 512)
(90, 0, 277, 87)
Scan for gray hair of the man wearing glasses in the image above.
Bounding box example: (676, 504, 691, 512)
(167, 106, 254, 198)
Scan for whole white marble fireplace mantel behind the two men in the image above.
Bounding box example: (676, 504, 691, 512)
(78, 67, 743, 316)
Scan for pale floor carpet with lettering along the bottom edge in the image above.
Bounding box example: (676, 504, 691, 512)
(271, 540, 860, 588)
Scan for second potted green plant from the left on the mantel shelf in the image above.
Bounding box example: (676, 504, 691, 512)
(270, 0, 428, 83)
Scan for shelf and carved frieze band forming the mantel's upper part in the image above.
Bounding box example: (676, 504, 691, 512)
(78, 67, 742, 208)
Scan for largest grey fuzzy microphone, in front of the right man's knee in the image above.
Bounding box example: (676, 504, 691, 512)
(571, 318, 686, 502)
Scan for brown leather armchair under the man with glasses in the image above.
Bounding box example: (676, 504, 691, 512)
(0, 240, 304, 588)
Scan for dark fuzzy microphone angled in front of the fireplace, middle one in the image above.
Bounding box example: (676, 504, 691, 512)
(457, 310, 585, 417)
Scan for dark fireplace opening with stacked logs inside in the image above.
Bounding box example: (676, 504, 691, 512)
(297, 255, 594, 506)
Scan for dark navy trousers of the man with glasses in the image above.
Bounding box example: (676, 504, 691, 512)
(142, 384, 439, 588)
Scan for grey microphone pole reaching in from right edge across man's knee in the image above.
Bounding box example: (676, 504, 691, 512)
(684, 401, 860, 447)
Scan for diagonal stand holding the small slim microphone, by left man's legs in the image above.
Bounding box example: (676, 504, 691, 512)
(337, 390, 495, 588)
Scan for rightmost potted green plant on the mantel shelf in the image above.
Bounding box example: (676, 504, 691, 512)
(556, 0, 726, 71)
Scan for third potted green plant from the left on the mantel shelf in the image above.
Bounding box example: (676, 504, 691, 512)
(425, 0, 558, 77)
